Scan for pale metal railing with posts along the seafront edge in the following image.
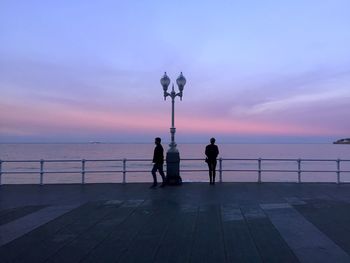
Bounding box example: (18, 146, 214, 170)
(0, 158, 350, 185)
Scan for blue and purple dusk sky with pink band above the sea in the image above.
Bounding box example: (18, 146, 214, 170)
(0, 0, 350, 143)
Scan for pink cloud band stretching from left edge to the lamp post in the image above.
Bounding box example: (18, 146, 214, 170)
(0, 100, 169, 134)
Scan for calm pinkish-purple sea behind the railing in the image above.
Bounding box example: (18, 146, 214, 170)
(0, 143, 350, 184)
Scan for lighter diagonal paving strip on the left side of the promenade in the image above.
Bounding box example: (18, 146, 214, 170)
(0, 204, 80, 246)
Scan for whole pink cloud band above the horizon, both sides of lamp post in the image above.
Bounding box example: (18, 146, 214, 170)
(0, 96, 344, 141)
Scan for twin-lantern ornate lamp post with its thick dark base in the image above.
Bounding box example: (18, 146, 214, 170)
(160, 72, 186, 185)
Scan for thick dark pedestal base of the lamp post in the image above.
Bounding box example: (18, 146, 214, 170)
(166, 147, 182, 185)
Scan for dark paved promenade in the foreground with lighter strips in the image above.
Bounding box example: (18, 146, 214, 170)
(0, 183, 350, 263)
